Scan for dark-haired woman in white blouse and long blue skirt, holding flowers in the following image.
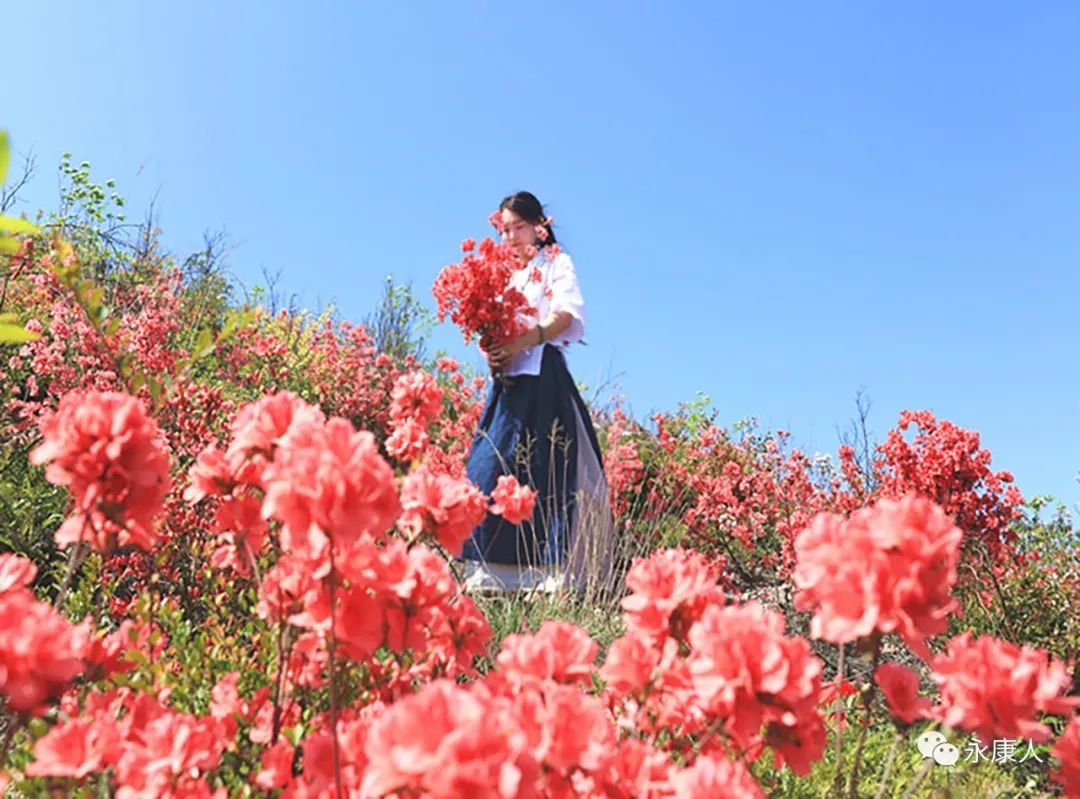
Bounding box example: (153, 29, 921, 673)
(462, 191, 612, 590)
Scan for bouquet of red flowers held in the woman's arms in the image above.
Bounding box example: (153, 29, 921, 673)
(432, 239, 536, 375)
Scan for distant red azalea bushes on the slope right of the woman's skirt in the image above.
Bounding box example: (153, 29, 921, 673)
(605, 397, 1023, 587)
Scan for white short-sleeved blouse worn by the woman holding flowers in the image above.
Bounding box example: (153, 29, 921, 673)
(482, 250, 585, 377)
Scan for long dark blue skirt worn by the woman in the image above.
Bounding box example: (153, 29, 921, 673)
(462, 344, 603, 566)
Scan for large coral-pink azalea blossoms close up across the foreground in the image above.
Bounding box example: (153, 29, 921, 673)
(0, 408, 1080, 796)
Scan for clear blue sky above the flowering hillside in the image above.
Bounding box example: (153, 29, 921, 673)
(0, 0, 1080, 505)
